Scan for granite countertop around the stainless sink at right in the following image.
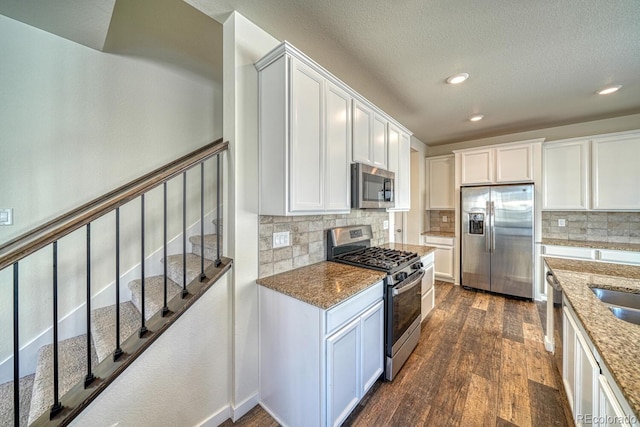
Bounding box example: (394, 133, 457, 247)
(545, 257, 640, 416)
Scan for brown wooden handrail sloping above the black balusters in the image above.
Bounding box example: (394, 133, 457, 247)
(0, 138, 229, 271)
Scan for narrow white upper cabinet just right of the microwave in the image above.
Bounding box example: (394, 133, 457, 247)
(387, 123, 411, 211)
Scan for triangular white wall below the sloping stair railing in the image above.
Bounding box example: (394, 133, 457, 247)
(71, 272, 232, 426)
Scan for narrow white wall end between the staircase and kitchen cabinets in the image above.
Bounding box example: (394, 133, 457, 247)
(224, 12, 279, 420)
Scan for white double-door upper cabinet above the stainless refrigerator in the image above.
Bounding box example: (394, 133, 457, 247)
(456, 139, 543, 185)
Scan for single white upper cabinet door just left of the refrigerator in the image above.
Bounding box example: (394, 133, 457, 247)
(427, 156, 455, 209)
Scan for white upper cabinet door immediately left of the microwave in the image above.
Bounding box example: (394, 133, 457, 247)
(324, 82, 351, 212)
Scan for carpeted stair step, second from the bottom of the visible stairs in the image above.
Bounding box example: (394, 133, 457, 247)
(29, 334, 98, 424)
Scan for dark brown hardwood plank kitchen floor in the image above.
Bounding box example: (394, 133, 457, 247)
(223, 282, 573, 427)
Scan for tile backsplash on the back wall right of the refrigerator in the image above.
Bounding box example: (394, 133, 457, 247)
(542, 211, 640, 243)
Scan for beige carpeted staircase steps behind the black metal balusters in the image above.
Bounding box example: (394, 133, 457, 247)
(0, 226, 222, 427)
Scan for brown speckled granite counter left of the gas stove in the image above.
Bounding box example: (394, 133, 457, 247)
(256, 261, 386, 310)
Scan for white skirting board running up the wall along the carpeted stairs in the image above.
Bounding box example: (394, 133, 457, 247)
(0, 210, 220, 384)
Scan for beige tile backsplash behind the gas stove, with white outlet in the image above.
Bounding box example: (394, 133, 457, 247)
(259, 209, 389, 277)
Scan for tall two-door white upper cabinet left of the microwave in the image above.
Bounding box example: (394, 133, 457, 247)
(256, 44, 352, 216)
